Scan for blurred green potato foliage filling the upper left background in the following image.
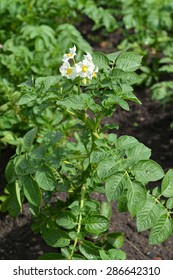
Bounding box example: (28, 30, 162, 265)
(0, 0, 119, 147)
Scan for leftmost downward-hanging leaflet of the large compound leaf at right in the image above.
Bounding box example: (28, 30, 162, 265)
(105, 172, 129, 201)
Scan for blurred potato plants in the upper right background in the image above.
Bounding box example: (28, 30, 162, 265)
(97, 0, 173, 103)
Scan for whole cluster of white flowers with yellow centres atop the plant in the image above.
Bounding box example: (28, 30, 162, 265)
(59, 46, 98, 80)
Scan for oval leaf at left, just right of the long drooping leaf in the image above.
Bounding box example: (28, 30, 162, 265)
(35, 166, 57, 191)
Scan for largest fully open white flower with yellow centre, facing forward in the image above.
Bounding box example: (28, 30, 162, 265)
(76, 59, 95, 79)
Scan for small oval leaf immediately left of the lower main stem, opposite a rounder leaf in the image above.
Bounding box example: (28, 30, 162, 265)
(56, 211, 77, 229)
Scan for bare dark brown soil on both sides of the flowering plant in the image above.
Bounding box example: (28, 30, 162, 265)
(0, 88, 173, 260)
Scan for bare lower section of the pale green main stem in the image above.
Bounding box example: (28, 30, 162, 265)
(68, 185, 86, 260)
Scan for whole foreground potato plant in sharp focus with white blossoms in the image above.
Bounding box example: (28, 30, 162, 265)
(1, 46, 173, 260)
